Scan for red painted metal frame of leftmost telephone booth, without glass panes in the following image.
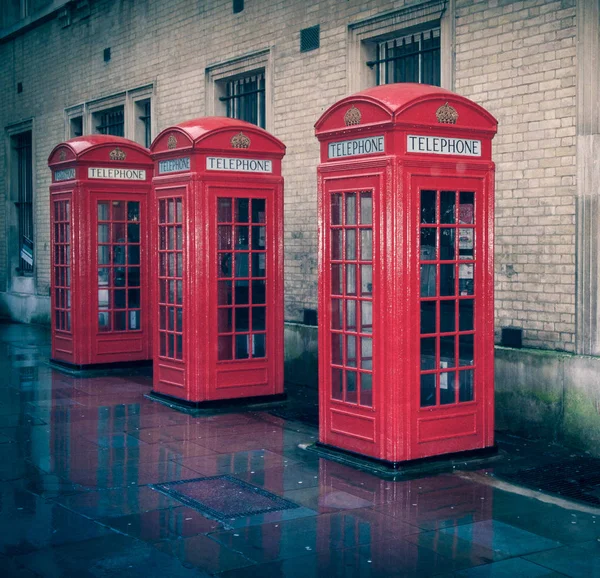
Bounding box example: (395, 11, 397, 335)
(48, 135, 153, 366)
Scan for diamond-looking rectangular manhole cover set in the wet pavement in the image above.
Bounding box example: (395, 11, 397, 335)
(152, 475, 300, 521)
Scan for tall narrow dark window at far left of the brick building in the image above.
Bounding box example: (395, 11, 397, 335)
(11, 131, 33, 274)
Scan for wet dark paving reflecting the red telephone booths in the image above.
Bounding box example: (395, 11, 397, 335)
(0, 324, 600, 578)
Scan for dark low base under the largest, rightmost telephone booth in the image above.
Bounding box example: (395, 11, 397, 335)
(300, 442, 503, 480)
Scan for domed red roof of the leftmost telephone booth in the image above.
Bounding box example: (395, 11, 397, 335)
(48, 134, 152, 166)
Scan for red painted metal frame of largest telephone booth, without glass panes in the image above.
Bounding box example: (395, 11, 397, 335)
(315, 84, 497, 462)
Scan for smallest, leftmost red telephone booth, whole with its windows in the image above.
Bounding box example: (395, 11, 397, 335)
(48, 135, 153, 368)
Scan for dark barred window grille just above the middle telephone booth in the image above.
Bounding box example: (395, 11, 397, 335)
(220, 72, 265, 128)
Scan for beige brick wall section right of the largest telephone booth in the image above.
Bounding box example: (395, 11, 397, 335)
(456, 0, 576, 351)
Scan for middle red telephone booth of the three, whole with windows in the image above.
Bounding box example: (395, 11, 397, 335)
(151, 117, 285, 406)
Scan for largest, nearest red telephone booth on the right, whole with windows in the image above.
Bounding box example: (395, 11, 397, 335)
(316, 84, 497, 463)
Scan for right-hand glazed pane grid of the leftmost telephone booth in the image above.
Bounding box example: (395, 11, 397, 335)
(97, 201, 142, 333)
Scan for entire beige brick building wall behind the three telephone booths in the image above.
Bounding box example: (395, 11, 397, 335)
(0, 0, 576, 350)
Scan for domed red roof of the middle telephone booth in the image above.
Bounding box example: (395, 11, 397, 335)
(150, 116, 285, 157)
